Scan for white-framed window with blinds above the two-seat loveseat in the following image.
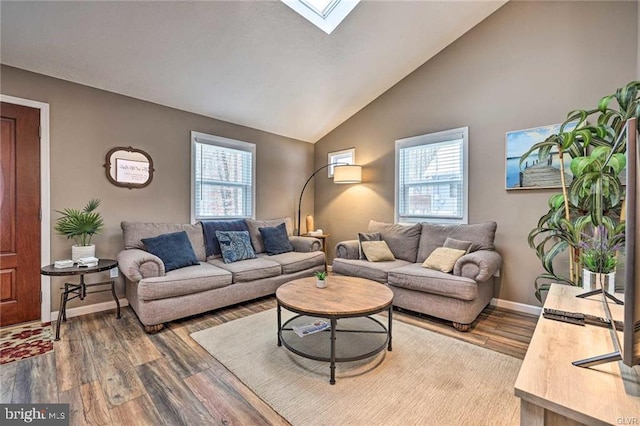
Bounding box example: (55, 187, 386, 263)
(396, 127, 468, 223)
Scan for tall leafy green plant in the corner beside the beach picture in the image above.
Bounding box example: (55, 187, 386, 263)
(520, 81, 640, 300)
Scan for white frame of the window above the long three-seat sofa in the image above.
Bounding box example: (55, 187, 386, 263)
(190, 131, 256, 223)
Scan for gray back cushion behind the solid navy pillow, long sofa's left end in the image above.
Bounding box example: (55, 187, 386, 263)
(120, 221, 207, 262)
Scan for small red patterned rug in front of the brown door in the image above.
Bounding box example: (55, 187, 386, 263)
(0, 322, 53, 365)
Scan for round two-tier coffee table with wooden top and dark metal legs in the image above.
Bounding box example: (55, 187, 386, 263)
(276, 276, 393, 385)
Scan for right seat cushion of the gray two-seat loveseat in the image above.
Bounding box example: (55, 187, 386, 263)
(388, 263, 478, 300)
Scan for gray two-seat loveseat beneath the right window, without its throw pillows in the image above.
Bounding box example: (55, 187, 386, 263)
(332, 221, 502, 331)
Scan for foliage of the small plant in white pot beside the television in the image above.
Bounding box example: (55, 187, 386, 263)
(579, 222, 624, 274)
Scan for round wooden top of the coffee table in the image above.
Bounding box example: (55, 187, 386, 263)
(276, 275, 393, 317)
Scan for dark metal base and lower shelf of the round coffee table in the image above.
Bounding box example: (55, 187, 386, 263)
(278, 303, 392, 385)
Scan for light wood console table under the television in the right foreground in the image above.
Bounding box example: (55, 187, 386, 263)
(515, 284, 640, 425)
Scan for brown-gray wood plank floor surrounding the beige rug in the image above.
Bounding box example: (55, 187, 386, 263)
(0, 297, 537, 426)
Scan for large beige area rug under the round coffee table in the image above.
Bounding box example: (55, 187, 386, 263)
(191, 309, 521, 425)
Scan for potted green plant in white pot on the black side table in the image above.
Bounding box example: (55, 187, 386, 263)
(54, 198, 104, 262)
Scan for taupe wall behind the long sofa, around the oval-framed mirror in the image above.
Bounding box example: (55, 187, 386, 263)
(0, 66, 314, 310)
